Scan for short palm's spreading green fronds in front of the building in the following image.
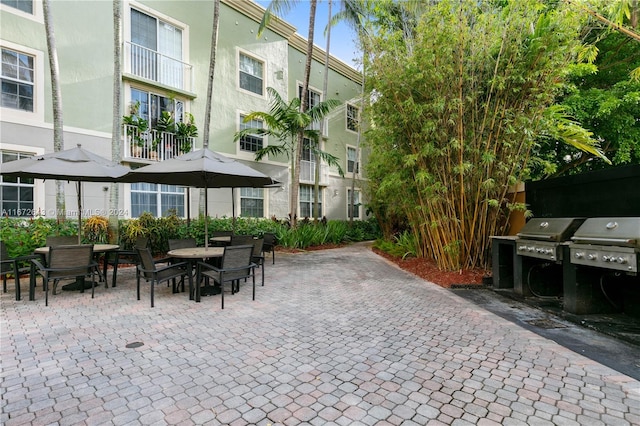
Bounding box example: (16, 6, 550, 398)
(234, 87, 344, 211)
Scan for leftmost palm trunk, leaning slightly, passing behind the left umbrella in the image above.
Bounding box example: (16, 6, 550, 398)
(42, 0, 66, 220)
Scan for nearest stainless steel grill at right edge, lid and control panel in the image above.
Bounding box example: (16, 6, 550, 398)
(570, 217, 640, 275)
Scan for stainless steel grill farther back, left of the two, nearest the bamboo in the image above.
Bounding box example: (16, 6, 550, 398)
(516, 218, 584, 262)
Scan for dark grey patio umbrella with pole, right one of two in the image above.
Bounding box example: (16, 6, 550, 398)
(120, 148, 279, 247)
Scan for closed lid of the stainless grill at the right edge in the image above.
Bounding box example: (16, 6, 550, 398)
(571, 217, 640, 248)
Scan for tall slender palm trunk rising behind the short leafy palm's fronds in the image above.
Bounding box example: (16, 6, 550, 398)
(289, 0, 318, 228)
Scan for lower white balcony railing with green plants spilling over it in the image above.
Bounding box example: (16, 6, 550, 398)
(122, 126, 196, 161)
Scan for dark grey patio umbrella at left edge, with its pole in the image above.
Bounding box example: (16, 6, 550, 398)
(0, 144, 131, 243)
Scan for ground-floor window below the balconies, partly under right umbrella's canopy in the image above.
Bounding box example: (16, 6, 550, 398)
(131, 183, 185, 217)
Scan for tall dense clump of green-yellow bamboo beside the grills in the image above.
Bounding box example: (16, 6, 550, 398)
(364, 0, 580, 270)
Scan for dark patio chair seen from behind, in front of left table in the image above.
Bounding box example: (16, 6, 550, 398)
(32, 244, 99, 306)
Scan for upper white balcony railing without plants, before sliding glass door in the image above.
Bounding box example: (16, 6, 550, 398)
(124, 42, 193, 91)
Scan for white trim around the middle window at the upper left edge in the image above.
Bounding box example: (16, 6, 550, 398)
(0, 40, 48, 125)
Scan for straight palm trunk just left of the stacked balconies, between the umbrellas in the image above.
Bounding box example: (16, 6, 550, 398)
(109, 0, 122, 244)
